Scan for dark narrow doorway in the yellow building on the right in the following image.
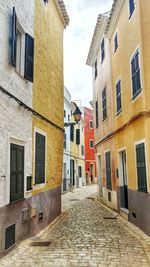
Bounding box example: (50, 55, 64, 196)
(119, 150, 128, 209)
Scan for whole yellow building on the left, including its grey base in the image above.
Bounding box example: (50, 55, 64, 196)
(32, 0, 69, 232)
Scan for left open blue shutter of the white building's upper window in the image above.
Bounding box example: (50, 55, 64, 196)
(10, 7, 17, 67)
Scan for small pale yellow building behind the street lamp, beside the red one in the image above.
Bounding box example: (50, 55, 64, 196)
(70, 102, 85, 187)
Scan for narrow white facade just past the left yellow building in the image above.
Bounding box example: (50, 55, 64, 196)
(62, 88, 71, 191)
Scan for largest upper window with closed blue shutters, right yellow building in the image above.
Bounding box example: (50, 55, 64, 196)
(131, 50, 141, 99)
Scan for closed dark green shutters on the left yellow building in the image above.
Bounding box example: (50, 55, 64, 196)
(35, 132, 46, 184)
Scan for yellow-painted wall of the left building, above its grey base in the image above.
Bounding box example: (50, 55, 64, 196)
(33, 0, 64, 194)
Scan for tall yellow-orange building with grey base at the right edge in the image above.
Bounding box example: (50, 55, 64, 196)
(107, 0, 150, 235)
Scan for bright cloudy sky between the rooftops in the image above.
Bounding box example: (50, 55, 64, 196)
(64, 0, 113, 107)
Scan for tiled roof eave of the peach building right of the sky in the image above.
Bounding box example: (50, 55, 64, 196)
(86, 15, 108, 66)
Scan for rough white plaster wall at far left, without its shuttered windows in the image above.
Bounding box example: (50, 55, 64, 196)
(0, 0, 34, 207)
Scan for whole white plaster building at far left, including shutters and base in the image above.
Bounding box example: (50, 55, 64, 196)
(0, 0, 34, 253)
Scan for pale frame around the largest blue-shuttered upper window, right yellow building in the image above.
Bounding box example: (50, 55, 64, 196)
(130, 46, 142, 101)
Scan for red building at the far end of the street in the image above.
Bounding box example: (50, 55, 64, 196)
(84, 107, 97, 184)
